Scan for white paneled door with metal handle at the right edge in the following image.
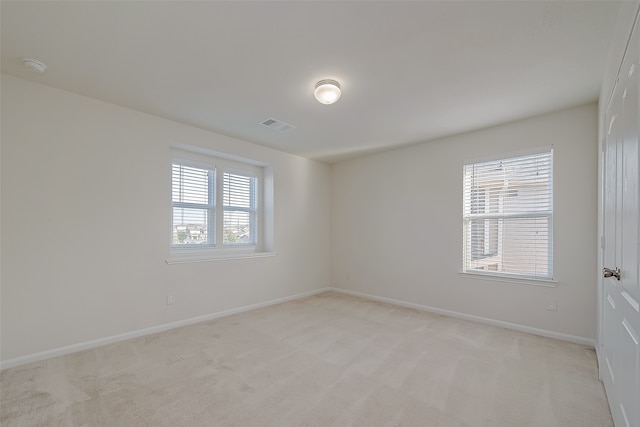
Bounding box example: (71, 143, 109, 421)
(600, 14, 640, 427)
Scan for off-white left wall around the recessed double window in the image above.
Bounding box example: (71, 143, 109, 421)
(0, 75, 330, 362)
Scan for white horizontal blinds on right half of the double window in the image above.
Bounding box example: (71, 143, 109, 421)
(222, 172, 258, 245)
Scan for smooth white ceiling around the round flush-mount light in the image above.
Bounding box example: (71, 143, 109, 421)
(1, 1, 619, 162)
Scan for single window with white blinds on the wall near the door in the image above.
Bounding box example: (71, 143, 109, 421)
(463, 148, 553, 280)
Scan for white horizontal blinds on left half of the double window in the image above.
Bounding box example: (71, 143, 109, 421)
(171, 161, 215, 246)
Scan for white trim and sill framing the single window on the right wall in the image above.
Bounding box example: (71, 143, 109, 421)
(458, 145, 558, 287)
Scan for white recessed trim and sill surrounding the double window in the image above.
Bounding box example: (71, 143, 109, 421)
(165, 145, 275, 264)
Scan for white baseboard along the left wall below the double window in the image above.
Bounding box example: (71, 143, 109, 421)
(0, 288, 332, 370)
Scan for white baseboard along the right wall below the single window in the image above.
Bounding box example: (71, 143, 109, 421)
(329, 288, 596, 349)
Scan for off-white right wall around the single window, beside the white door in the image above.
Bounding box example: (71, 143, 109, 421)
(331, 104, 598, 342)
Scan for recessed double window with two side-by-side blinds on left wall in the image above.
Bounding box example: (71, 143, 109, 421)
(170, 147, 263, 260)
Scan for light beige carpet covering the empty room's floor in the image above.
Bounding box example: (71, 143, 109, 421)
(0, 292, 613, 427)
